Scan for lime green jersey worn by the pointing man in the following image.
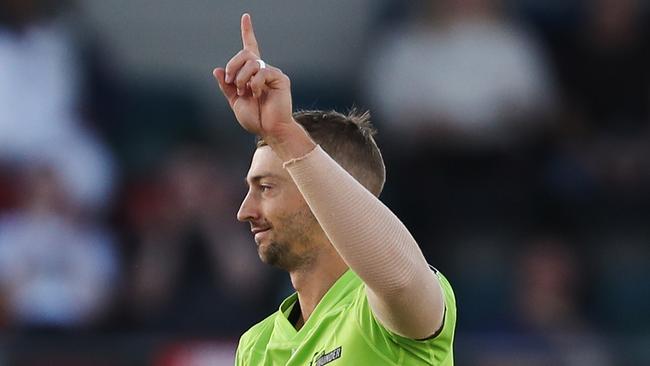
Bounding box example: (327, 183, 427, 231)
(236, 270, 456, 366)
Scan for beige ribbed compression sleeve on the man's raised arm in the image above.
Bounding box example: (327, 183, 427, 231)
(285, 147, 444, 338)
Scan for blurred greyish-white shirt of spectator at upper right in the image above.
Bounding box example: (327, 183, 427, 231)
(366, 17, 552, 143)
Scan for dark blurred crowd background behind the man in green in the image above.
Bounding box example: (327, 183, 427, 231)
(0, 0, 650, 366)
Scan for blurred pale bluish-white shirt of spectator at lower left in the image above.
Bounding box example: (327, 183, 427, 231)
(0, 211, 119, 327)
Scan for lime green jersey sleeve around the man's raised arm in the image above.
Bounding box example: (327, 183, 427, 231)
(356, 272, 456, 366)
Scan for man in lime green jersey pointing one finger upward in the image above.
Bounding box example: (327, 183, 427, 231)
(214, 14, 456, 366)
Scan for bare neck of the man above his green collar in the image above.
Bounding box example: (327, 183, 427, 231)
(289, 248, 348, 329)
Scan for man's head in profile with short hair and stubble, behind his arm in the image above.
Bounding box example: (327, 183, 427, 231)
(237, 111, 386, 271)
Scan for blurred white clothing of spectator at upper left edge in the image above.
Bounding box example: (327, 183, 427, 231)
(0, 22, 114, 208)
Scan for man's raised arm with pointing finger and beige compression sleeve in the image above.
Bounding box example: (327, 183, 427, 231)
(214, 14, 445, 339)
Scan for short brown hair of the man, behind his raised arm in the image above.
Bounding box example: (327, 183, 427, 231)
(257, 109, 386, 196)
